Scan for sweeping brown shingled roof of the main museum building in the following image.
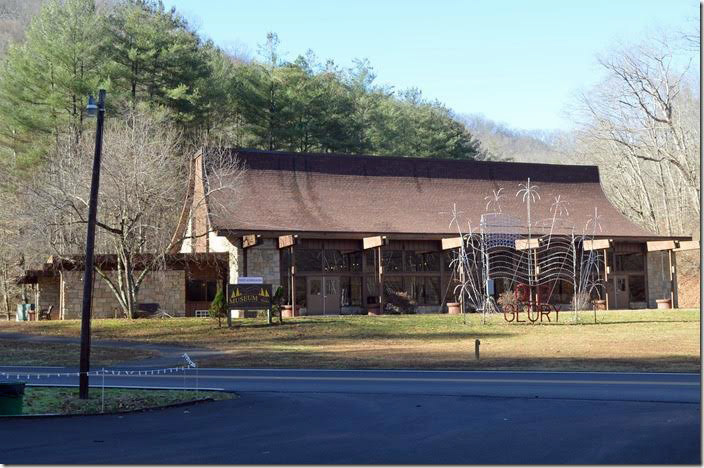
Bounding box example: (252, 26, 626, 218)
(209, 149, 672, 239)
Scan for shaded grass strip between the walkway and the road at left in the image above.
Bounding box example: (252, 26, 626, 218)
(0, 340, 158, 367)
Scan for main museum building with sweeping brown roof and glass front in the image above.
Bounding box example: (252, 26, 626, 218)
(176, 148, 698, 315)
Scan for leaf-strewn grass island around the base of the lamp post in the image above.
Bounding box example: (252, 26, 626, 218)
(11, 387, 234, 414)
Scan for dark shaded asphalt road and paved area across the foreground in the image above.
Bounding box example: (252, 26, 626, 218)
(0, 368, 701, 464)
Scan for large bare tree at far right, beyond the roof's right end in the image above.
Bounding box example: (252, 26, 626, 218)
(576, 35, 700, 235)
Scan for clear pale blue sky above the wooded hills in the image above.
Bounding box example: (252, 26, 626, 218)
(164, 0, 699, 130)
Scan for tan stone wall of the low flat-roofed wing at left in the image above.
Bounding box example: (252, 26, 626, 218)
(62, 270, 186, 319)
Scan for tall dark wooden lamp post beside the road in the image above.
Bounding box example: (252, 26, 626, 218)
(78, 89, 105, 399)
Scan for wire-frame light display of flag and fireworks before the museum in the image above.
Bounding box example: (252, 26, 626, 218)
(450, 179, 606, 322)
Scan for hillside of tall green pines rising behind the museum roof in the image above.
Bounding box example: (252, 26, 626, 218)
(0, 0, 483, 167)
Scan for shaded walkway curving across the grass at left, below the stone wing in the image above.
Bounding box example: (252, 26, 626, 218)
(0, 331, 222, 367)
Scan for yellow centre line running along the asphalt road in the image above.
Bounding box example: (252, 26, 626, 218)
(57, 375, 699, 387)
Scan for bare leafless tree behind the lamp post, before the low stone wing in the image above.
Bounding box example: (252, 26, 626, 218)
(24, 110, 242, 317)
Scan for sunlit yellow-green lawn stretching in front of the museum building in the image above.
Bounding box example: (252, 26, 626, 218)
(0, 309, 700, 372)
